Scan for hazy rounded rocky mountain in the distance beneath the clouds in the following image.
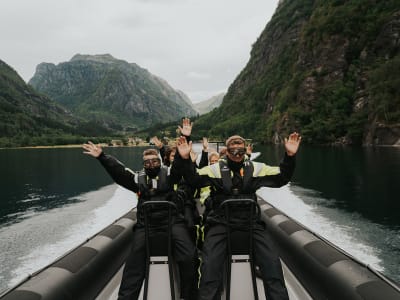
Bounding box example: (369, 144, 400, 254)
(29, 54, 196, 130)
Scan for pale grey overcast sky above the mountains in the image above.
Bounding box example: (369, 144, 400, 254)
(0, 0, 278, 102)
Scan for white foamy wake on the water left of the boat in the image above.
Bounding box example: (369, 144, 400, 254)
(0, 184, 137, 290)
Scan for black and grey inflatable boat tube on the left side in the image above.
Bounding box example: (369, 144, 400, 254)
(0, 211, 136, 300)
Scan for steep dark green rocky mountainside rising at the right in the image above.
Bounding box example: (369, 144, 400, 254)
(195, 0, 400, 145)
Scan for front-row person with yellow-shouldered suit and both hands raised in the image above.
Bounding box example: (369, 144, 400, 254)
(174, 133, 301, 300)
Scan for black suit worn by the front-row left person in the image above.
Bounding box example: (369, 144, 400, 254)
(98, 154, 198, 300)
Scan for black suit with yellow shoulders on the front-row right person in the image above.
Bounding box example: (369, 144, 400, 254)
(175, 154, 295, 300)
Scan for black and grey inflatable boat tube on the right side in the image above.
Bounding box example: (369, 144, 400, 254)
(258, 199, 400, 300)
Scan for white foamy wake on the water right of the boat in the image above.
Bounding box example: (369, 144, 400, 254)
(258, 185, 385, 272)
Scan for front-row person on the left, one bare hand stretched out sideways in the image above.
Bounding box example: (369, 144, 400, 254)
(83, 142, 198, 300)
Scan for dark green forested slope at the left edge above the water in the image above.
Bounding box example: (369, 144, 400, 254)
(0, 60, 117, 147)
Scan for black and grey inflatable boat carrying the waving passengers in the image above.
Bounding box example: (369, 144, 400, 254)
(0, 197, 400, 300)
